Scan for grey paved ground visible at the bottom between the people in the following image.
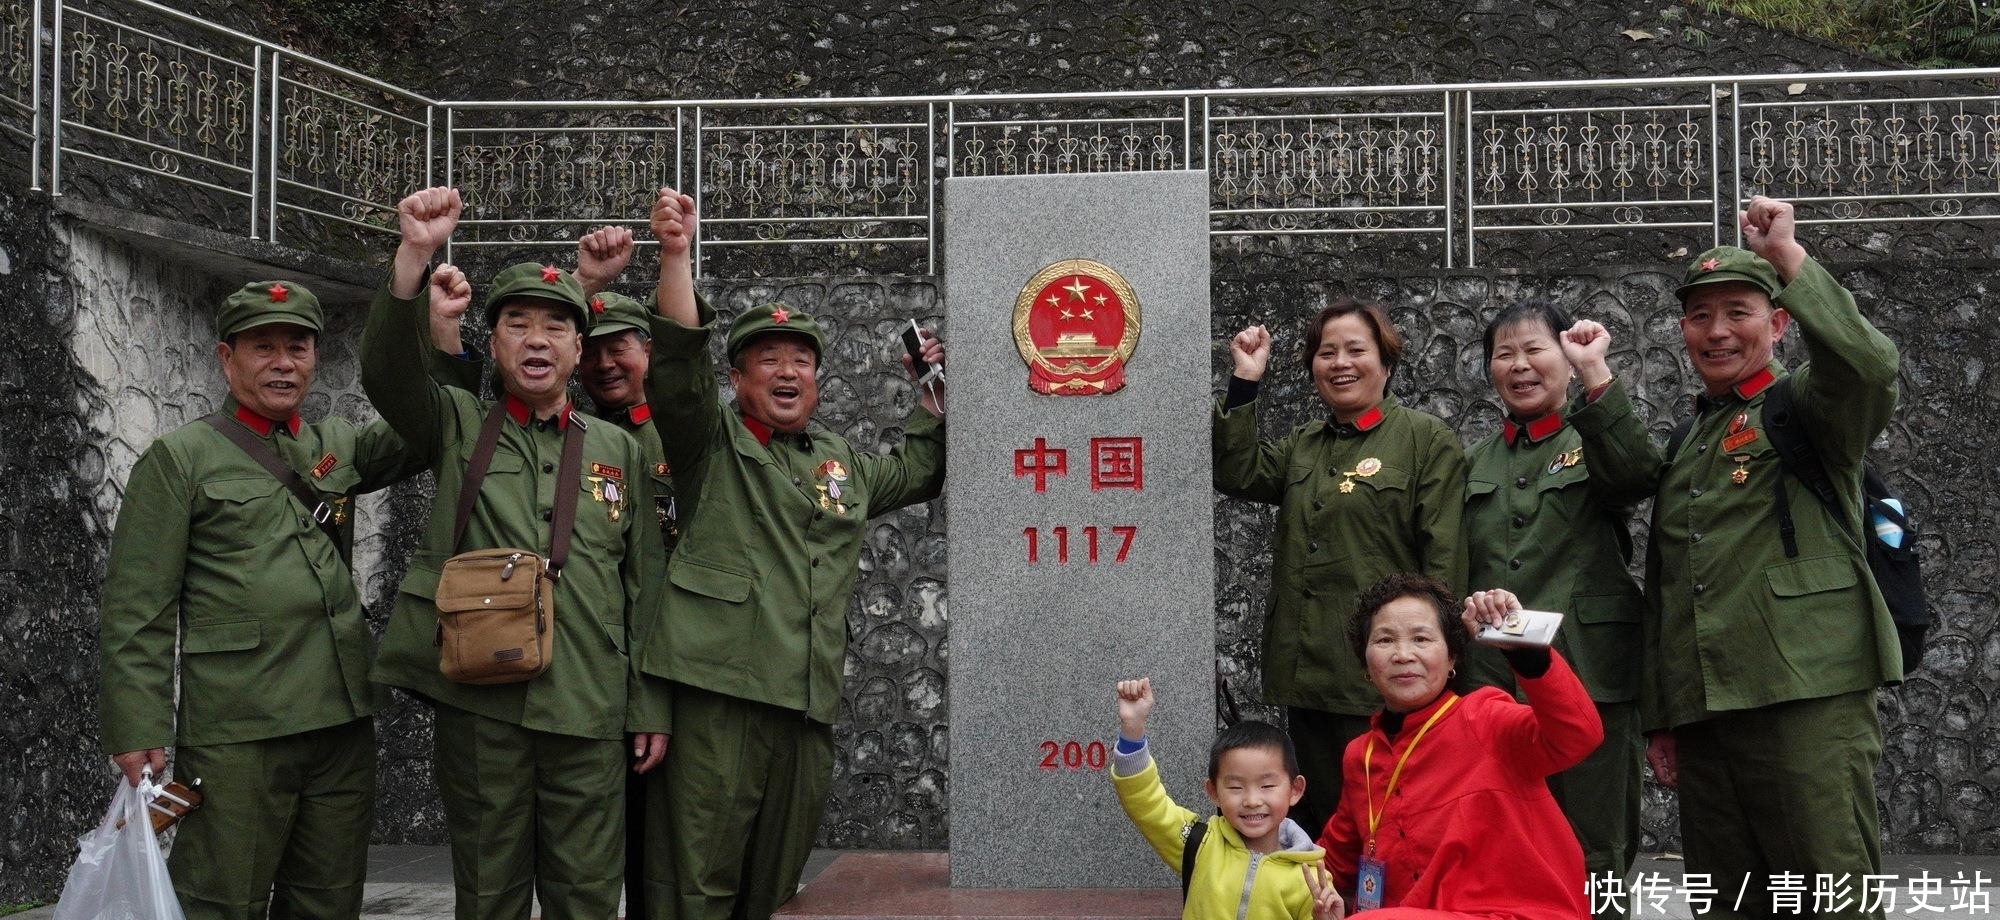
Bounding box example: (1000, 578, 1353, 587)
(10, 846, 2000, 920)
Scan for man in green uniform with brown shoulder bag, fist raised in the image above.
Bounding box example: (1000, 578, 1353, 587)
(362, 188, 672, 920)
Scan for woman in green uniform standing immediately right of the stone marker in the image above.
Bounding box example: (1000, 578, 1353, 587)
(1212, 300, 1466, 828)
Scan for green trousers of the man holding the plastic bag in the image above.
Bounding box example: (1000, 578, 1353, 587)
(166, 718, 376, 920)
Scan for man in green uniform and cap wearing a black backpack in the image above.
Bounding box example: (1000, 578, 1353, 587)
(1640, 196, 1902, 916)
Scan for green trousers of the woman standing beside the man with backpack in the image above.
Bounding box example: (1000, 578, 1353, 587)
(1548, 702, 1646, 916)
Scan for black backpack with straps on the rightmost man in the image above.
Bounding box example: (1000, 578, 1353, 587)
(1666, 378, 1932, 684)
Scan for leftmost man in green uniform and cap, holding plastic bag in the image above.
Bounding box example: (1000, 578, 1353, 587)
(98, 282, 422, 920)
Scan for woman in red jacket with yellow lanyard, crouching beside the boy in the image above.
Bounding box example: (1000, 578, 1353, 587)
(1320, 574, 1604, 920)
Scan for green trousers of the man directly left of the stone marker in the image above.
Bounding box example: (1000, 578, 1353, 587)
(644, 684, 834, 920)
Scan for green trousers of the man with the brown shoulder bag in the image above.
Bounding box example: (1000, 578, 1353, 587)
(432, 704, 626, 920)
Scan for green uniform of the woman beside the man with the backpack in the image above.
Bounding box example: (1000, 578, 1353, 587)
(1464, 380, 1660, 904)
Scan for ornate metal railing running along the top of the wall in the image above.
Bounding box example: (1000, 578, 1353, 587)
(0, 0, 2000, 272)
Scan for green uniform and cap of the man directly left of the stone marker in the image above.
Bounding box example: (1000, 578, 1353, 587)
(640, 304, 944, 920)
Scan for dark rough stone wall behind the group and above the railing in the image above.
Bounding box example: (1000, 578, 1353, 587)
(0, 0, 2000, 904)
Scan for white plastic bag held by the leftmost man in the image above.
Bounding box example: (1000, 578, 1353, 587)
(56, 770, 184, 920)
